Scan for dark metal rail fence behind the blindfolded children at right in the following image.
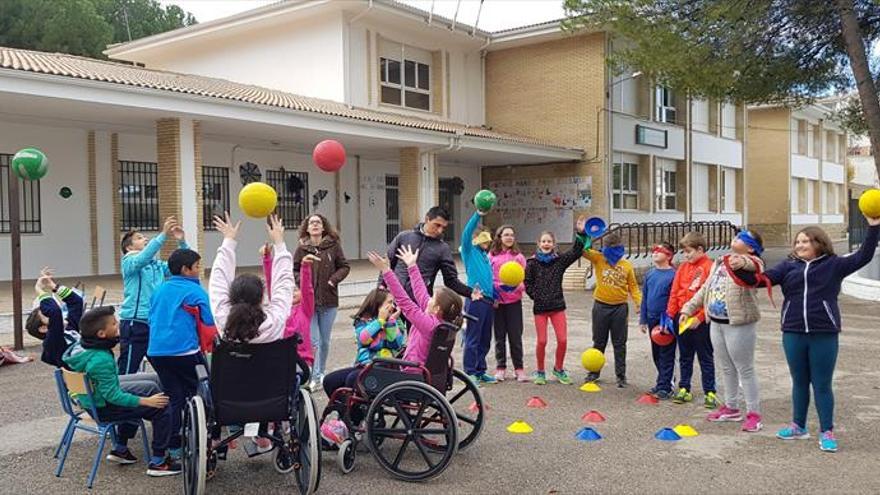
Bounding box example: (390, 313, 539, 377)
(593, 221, 740, 259)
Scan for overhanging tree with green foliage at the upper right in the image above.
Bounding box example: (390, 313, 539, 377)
(564, 0, 880, 178)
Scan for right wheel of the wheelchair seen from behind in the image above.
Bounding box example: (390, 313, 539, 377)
(291, 389, 321, 495)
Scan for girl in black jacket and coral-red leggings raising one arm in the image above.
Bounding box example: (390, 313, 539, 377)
(525, 217, 586, 385)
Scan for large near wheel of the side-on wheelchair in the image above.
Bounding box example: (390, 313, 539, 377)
(367, 381, 458, 481)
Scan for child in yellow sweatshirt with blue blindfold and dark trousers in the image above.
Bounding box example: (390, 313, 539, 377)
(584, 233, 642, 388)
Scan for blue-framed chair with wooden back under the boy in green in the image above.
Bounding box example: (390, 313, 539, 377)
(55, 368, 150, 488)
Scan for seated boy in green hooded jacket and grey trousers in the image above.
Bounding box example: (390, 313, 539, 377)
(63, 306, 181, 476)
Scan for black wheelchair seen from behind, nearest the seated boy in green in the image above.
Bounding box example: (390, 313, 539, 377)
(182, 335, 321, 495)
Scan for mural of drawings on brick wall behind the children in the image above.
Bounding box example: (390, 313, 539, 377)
(489, 177, 593, 243)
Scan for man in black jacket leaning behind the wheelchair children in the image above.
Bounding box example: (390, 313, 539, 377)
(379, 206, 472, 298)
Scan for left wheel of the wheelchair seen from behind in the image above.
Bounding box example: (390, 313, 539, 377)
(181, 395, 210, 495)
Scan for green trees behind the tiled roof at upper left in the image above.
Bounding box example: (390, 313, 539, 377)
(0, 0, 196, 58)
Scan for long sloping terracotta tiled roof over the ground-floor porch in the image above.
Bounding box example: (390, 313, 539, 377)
(0, 47, 580, 151)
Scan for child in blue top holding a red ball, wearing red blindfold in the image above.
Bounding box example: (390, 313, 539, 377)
(639, 242, 675, 400)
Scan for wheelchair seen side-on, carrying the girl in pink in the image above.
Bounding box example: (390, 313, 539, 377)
(321, 315, 485, 481)
